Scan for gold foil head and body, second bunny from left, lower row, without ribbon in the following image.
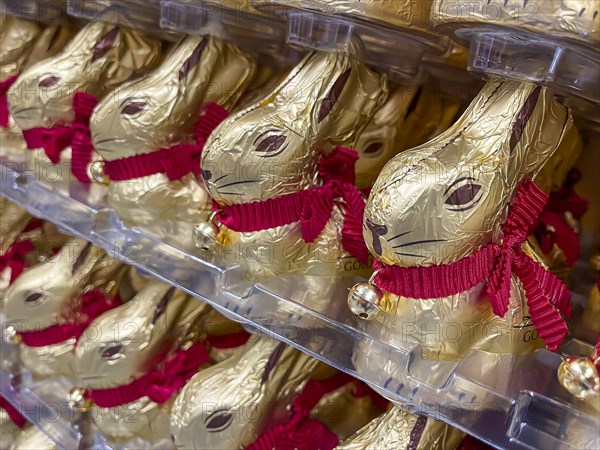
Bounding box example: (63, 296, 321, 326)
(75, 281, 209, 442)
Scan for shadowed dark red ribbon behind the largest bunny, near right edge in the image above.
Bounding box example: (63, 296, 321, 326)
(534, 169, 588, 266)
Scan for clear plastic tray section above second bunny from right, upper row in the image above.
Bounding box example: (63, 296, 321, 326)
(251, 1, 448, 83)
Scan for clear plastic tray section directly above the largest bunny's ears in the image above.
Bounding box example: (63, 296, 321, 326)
(454, 25, 600, 104)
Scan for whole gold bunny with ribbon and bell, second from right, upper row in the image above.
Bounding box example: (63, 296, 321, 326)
(197, 53, 387, 279)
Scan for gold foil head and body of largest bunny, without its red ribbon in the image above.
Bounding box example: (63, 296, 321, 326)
(363, 80, 572, 359)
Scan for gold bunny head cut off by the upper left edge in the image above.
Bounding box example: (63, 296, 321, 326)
(0, 14, 42, 81)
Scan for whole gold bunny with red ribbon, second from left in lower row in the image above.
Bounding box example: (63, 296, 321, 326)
(75, 281, 209, 443)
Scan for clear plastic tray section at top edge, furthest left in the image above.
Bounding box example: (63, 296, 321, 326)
(67, 0, 182, 41)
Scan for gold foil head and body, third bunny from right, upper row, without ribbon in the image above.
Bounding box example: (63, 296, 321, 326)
(90, 36, 256, 237)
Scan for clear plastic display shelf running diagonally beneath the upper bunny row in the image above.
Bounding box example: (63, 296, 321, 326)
(0, 165, 600, 450)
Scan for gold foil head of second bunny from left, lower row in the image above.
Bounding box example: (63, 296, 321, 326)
(75, 281, 208, 389)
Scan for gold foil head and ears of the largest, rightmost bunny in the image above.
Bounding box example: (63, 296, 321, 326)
(363, 80, 572, 267)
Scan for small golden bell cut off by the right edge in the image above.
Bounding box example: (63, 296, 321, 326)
(557, 356, 600, 400)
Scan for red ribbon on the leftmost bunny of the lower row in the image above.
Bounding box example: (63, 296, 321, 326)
(19, 290, 121, 347)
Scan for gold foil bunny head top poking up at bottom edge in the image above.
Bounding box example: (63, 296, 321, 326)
(336, 407, 465, 450)
